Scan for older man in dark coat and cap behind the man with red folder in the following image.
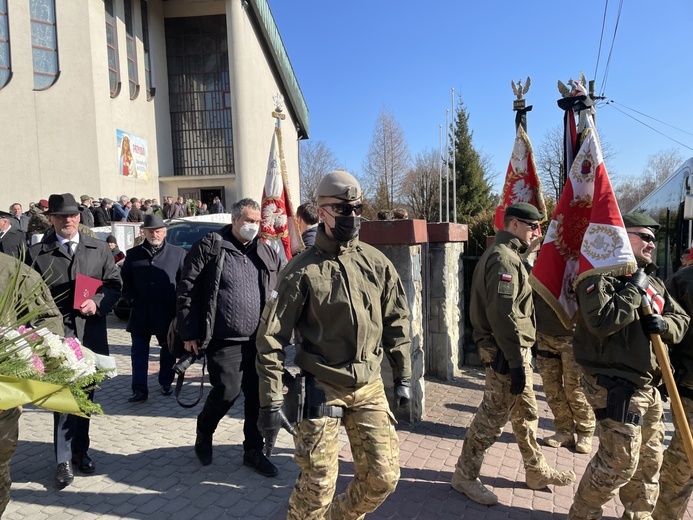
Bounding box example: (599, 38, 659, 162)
(120, 213, 185, 403)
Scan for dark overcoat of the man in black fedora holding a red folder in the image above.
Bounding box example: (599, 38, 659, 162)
(27, 231, 122, 355)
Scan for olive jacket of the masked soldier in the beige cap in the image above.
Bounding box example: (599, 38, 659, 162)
(256, 224, 411, 406)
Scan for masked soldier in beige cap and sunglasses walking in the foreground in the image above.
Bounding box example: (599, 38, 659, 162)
(256, 171, 411, 520)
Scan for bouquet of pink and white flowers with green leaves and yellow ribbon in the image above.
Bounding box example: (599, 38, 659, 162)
(0, 255, 115, 417)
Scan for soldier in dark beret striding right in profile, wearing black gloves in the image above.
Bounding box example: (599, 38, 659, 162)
(452, 203, 575, 505)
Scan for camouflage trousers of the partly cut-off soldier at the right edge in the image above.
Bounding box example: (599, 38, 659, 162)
(652, 397, 693, 520)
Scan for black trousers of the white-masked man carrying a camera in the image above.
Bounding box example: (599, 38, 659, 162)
(197, 340, 264, 450)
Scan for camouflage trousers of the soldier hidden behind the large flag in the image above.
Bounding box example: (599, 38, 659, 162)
(537, 334, 596, 437)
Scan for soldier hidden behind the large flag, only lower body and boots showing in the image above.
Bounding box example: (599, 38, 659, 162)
(534, 293, 596, 453)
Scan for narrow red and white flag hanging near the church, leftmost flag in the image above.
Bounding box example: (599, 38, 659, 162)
(260, 127, 297, 263)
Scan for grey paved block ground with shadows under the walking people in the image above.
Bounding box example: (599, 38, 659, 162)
(3, 317, 693, 520)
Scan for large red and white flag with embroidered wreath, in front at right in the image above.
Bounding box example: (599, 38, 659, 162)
(529, 116, 637, 327)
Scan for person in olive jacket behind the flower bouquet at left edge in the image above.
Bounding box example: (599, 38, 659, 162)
(0, 253, 63, 517)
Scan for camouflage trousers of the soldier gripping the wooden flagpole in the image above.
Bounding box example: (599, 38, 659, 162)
(568, 375, 664, 520)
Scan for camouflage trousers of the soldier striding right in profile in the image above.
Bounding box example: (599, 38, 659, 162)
(455, 349, 548, 480)
